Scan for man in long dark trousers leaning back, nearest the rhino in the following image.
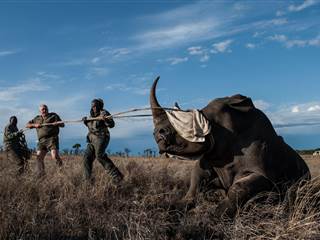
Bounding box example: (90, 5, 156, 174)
(82, 99, 123, 184)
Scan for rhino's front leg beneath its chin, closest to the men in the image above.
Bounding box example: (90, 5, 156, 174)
(183, 161, 220, 201)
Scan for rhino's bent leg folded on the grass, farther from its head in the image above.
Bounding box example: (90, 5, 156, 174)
(214, 173, 274, 218)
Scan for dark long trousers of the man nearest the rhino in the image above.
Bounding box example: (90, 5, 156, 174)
(83, 137, 123, 181)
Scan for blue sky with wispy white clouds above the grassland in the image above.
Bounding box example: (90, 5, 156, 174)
(0, 0, 320, 152)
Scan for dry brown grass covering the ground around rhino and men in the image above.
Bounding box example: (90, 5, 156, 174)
(0, 156, 320, 239)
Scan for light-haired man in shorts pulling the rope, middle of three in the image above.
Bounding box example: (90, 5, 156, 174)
(26, 104, 64, 177)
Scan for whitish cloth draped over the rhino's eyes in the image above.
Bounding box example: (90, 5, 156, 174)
(166, 109, 211, 142)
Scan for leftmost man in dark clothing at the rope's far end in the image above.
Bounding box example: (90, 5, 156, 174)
(3, 116, 30, 175)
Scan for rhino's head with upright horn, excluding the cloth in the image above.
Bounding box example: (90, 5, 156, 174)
(150, 77, 208, 157)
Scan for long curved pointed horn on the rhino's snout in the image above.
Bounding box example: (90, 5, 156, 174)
(150, 76, 167, 127)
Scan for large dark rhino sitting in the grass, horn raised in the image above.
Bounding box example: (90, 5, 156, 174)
(150, 77, 310, 217)
